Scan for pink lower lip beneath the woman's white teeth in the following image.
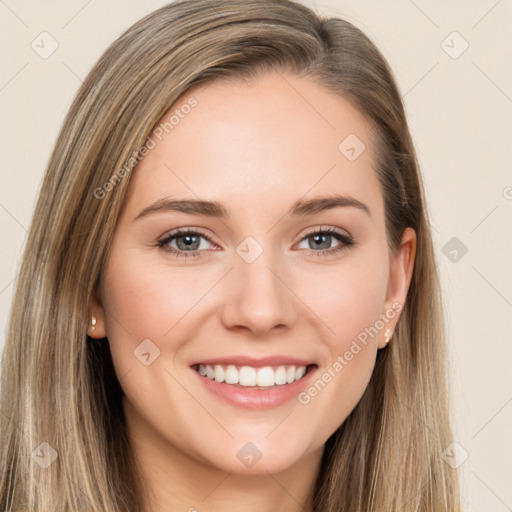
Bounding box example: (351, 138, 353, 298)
(191, 366, 318, 410)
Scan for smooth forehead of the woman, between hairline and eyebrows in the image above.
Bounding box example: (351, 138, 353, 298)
(125, 73, 383, 224)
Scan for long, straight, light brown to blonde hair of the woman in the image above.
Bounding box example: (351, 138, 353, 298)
(0, 0, 460, 512)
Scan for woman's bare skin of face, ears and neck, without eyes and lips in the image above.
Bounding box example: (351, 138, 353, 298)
(90, 69, 416, 512)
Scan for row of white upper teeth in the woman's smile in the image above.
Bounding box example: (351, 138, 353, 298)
(197, 364, 306, 387)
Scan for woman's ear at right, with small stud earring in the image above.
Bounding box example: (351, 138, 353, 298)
(379, 227, 416, 348)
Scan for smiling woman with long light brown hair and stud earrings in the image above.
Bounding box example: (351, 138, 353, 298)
(0, 0, 460, 512)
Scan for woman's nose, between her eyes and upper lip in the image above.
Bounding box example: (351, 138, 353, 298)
(221, 251, 297, 337)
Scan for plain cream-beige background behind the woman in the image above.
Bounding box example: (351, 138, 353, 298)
(0, 0, 512, 512)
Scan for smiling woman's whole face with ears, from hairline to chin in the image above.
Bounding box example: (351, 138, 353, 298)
(92, 74, 415, 474)
